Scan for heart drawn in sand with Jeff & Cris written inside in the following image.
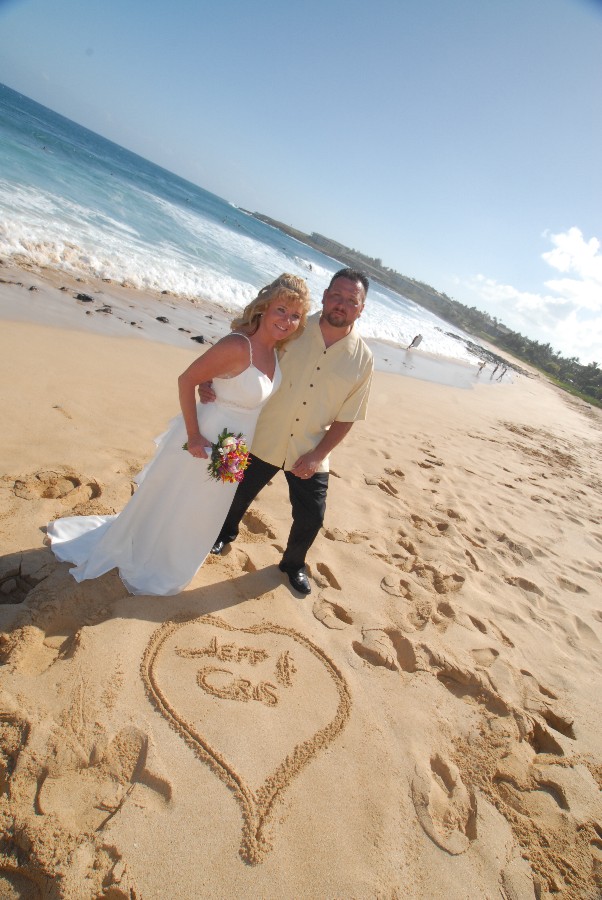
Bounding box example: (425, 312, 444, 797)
(141, 615, 351, 864)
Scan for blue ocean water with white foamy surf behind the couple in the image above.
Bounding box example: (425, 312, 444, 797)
(0, 85, 475, 362)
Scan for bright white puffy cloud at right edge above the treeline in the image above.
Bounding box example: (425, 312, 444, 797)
(466, 228, 602, 363)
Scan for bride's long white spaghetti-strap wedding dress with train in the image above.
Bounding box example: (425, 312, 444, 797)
(48, 342, 281, 595)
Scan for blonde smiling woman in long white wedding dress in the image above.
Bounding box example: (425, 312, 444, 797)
(48, 274, 310, 595)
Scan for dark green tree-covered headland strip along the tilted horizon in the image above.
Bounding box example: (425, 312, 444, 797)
(253, 213, 602, 406)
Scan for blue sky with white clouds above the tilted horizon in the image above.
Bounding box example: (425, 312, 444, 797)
(0, 0, 602, 364)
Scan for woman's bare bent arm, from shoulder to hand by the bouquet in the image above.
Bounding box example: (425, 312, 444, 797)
(178, 335, 249, 459)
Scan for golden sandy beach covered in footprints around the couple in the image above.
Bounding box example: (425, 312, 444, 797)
(0, 266, 602, 900)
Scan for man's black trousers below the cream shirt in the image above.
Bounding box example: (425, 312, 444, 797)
(216, 456, 328, 571)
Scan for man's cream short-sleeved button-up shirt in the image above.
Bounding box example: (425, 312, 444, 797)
(251, 313, 374, 472)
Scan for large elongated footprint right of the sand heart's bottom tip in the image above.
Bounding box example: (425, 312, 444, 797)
(412, 754, 477, 856)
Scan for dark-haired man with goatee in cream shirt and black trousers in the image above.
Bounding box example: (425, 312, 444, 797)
(200, 269, 373, 594)
